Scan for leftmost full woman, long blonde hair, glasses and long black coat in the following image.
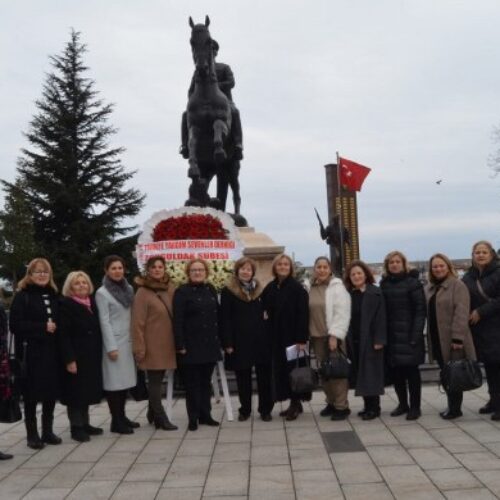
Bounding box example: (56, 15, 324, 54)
(10, 258, 62, 449)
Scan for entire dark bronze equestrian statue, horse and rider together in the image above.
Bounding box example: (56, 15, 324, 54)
(179, 16, 246, 225)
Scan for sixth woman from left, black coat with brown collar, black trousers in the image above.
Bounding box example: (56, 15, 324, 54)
(221, 257, 273, 422)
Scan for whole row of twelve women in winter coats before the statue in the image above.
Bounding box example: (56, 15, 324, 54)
(3, 241, 500, 449)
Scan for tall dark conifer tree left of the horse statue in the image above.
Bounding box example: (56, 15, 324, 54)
(3, 31, 144, 288)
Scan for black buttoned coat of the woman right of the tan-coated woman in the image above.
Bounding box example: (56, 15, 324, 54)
(173, 284, 222, 365)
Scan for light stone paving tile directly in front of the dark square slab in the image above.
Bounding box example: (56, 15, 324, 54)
(330, 451, 382, 484)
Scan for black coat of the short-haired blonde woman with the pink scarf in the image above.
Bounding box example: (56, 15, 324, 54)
(59, 297, 102, 405)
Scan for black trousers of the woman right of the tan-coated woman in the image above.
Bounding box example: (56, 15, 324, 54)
(180, 363, 215, 422)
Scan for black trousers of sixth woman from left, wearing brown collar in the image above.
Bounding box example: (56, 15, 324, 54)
(234, 364, 274, 416)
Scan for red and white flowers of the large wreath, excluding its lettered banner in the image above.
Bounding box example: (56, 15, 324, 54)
(138, 207, 243, 291)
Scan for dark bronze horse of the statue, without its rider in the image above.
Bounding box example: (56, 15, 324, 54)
(186, 16, 240, 214)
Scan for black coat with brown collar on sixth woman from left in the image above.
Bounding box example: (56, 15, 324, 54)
(221, 278, 271, 370)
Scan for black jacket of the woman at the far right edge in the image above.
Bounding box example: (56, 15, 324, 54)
(463, 259, 500, 363)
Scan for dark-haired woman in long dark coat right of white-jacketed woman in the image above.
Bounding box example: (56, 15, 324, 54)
(344, 260, 387, 420)
